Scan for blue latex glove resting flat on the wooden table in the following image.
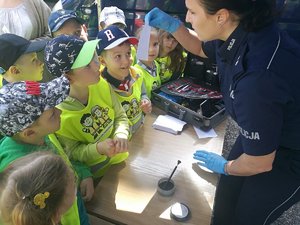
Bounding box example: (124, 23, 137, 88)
(194, 150, 228, 175)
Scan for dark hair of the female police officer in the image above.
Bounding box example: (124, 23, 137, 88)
(199, 0, 279, 31)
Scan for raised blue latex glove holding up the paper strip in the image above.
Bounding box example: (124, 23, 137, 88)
(145, 8, 181, 33)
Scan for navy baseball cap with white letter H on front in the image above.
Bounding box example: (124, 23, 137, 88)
(97, 25, 139, 55)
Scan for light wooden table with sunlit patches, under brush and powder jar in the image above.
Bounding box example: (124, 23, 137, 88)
(87, 108, 225, 225)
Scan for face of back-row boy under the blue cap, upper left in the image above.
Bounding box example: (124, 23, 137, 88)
(53, 19, 88, 41)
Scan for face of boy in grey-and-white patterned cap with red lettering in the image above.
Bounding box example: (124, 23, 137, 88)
(32, 108, 61, 136)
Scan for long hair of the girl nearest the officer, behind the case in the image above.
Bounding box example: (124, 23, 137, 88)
(159, 30, 185, 74)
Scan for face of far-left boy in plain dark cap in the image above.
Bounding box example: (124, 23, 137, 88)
(15, 52, 44, 81)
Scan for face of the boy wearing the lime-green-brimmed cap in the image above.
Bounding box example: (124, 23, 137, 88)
(68, 53, 100, 87)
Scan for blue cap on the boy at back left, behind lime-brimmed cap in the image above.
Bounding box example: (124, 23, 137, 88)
(48, 9, 85, 33)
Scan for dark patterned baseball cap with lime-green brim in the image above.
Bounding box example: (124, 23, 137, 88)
(44, 35, 99, 77)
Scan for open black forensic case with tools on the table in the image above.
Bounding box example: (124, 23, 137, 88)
(151, 53, 226, 129)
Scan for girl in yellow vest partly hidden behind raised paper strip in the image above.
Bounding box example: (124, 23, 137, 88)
(134, 27, 161, 98)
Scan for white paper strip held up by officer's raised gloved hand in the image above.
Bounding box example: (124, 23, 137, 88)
(136, 23, 151, 60)
